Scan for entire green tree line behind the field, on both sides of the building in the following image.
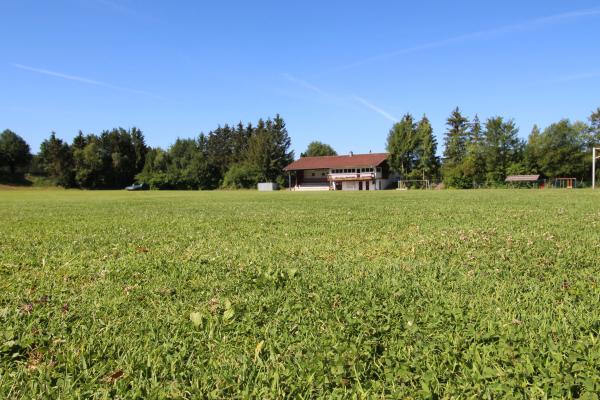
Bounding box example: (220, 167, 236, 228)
(0, 107, 600, 189)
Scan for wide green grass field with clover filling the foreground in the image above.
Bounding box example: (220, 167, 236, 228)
(0, 190, 600, 399)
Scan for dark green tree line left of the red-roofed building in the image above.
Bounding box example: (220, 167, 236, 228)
(0, 115, 294, 189)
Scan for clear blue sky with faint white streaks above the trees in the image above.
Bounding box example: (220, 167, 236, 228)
(0, 0, 600, 154)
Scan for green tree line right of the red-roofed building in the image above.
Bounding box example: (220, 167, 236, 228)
(387, 107, 600, 188)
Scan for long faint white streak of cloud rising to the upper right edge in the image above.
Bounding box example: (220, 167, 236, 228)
(325, 8, 600, 73)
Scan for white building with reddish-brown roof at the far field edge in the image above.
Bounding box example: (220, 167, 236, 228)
(284, 153, 392, 190)
